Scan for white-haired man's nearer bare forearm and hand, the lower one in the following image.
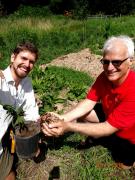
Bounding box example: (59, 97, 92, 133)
(46, 122, 118, 138)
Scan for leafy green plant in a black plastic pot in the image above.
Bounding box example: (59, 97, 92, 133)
(3, 105, 40, 158)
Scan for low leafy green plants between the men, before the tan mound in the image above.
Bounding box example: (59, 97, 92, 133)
(31, 66, 92, 113)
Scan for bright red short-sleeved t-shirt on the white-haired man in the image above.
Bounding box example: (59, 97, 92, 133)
(87, 71, 135, 144)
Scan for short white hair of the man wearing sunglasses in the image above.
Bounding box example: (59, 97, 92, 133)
(103, 35, 134, 58)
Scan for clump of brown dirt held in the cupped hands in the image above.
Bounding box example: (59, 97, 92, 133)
(41, 112, 63, 124)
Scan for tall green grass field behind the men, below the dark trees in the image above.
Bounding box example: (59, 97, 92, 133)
(0, 8, 135, 68)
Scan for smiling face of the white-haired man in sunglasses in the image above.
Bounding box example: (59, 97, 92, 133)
(103, 42, 131, 86)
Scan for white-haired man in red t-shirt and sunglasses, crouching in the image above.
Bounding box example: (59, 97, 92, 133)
(42, 36, 135, 168)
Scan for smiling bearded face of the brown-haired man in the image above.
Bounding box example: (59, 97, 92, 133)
(11, 50, 36, 82)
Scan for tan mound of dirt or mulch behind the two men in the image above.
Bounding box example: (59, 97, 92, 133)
(47, 48, 102, 78)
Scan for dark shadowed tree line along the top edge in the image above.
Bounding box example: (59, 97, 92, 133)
(0, 0, 135, 18)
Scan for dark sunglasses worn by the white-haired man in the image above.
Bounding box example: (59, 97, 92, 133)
(100, 57, 129, 67)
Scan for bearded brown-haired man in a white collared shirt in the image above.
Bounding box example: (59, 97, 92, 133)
(0, 42, 40, 180)
